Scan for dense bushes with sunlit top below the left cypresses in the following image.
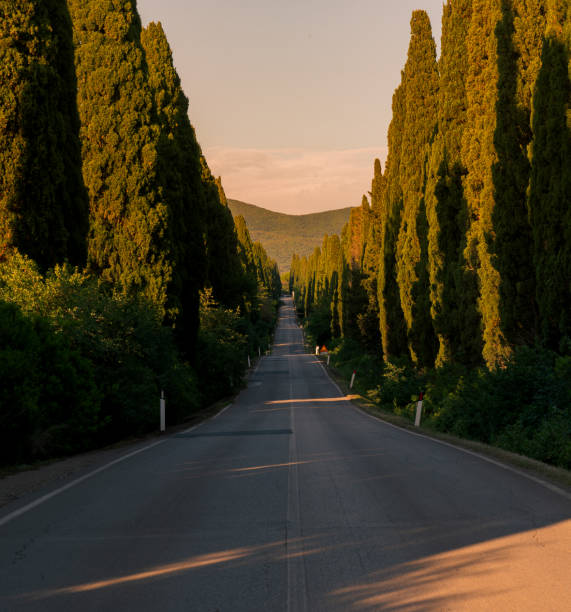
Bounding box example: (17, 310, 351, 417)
(0, 257, 200, 463)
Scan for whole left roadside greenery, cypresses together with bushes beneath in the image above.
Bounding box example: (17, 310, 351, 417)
(0, 0, 281, 461)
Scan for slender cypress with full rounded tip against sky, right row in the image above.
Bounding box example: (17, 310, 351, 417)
(396, 11, 438, 360)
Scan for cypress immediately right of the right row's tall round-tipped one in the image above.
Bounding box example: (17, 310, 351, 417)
(425, 0, 482, 365)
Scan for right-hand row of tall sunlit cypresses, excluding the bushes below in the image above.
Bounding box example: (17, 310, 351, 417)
(290, 0, 571, 369)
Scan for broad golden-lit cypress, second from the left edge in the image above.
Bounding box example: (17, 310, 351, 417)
(68, 0, 171, 308)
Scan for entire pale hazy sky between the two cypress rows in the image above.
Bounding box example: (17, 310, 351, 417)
(137, 0, 442, 214)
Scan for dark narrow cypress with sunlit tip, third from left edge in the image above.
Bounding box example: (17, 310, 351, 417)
(141, 23, 206, 352)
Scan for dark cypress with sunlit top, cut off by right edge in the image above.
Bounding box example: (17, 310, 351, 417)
(529, 0, 571, 351)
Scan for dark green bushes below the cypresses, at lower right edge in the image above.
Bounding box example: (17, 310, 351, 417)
(434, 347, 571, 468)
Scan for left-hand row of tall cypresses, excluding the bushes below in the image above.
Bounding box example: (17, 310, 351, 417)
(0, 0, 280, 357)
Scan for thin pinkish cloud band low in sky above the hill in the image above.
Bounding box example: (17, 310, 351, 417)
(205, 147, 386, 214)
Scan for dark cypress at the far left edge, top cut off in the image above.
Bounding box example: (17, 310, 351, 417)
(0, 0, 88, 269)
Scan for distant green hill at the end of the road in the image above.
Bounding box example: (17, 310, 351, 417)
(228, 200, 351, 274)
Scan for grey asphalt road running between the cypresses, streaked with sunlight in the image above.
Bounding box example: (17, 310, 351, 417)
(0, 300, 571, 612)
